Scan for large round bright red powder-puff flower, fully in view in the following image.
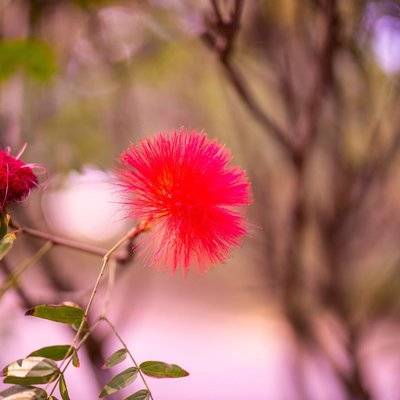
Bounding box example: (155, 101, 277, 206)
(117, 129, 249, 270)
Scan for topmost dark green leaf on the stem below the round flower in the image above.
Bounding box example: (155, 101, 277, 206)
(25, 304, 84, 326)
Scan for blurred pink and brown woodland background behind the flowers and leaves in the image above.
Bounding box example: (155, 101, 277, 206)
(0, 0, 400, 400)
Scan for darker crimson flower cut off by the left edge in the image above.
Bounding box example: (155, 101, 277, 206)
(0, 150, 38, 211)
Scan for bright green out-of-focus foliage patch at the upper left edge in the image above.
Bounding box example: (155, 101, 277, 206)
(0, 39, 56, 82)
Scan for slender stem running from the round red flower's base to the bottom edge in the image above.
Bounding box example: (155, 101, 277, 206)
(48, 222, 147, 399)
